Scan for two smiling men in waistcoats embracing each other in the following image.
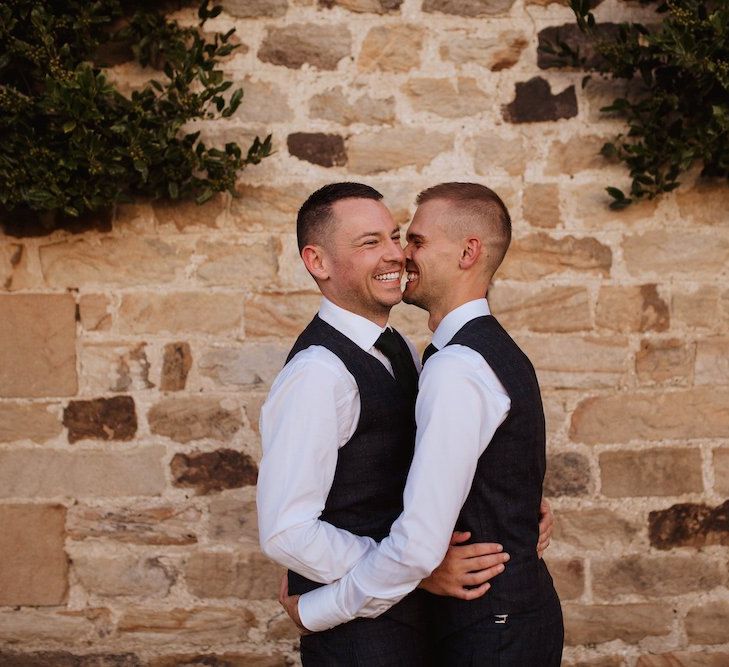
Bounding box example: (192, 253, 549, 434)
(258, 183, 564, 667)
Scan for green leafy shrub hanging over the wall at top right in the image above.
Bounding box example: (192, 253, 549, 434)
(553, 0, 729, 209)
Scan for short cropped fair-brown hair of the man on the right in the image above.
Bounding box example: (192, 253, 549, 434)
(415, 183, 511, 274)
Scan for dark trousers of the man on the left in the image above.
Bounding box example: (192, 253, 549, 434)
(301, 616, 433, 667)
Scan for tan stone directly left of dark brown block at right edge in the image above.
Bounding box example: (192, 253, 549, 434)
(554, 508, 641, 551)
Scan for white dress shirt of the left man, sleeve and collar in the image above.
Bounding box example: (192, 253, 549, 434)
(257, 299, 420, 583)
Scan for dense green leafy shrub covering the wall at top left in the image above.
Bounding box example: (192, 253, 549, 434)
(0, 0, 271, 224)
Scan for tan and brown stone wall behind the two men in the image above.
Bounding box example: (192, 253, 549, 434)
(0, 0, 729, 667)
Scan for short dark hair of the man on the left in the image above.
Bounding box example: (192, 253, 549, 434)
(296, 183, 382, 252)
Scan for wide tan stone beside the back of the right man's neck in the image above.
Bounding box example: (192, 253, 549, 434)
(496, 232, 613, 281)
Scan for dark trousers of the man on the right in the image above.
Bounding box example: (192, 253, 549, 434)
(436, 594, 564, 667)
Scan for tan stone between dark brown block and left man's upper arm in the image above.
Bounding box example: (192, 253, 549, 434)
(147, 396, 242, 443)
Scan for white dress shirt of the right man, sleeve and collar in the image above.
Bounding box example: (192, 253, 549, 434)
(299, 299, 511, 631)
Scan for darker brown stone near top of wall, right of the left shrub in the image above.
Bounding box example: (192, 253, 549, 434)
(258, 23, 352, 70)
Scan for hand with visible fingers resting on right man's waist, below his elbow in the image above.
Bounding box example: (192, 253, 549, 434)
(420, 532, 509, 600)
